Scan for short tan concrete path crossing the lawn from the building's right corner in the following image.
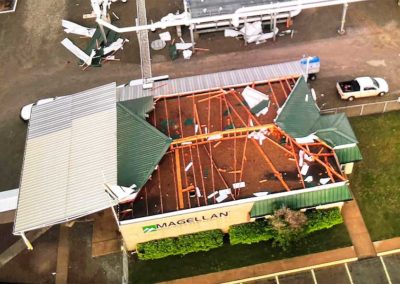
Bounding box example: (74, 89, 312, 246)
(342, 200, 376, 259)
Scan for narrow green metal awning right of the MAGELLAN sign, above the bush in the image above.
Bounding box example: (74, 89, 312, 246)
(250, 185, 353, 218)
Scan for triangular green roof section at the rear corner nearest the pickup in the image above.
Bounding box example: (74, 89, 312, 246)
(275, 77, 320, 138)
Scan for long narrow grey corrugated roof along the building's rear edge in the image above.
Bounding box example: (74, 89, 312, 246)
(118, 61, 304, 101)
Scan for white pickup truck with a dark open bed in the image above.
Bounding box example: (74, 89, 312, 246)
(336, 77, 389, 101)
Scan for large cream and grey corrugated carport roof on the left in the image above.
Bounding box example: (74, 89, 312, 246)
(14, 83, 117, 234)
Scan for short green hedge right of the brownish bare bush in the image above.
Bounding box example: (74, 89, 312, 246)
(305, 208, 343, 234)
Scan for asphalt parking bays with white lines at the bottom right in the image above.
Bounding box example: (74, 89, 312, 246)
(241, 254, 400, 284)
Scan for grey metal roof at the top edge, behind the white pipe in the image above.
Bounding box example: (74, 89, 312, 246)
(186, 0, 293, 18)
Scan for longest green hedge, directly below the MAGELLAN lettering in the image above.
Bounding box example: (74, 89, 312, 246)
(137, 230, 224, 260)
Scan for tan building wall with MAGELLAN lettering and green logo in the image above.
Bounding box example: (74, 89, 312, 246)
(120, 202, 254, 250)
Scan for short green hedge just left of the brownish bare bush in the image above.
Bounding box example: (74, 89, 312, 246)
(229, 220, 274, 245)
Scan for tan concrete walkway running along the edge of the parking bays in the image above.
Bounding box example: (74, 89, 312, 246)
(164, 247, 357, 284)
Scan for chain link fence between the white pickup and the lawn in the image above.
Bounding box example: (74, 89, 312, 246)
(321, 98, 400, 117)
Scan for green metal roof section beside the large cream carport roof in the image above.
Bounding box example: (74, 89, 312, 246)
(117, 103, 172, 189)
